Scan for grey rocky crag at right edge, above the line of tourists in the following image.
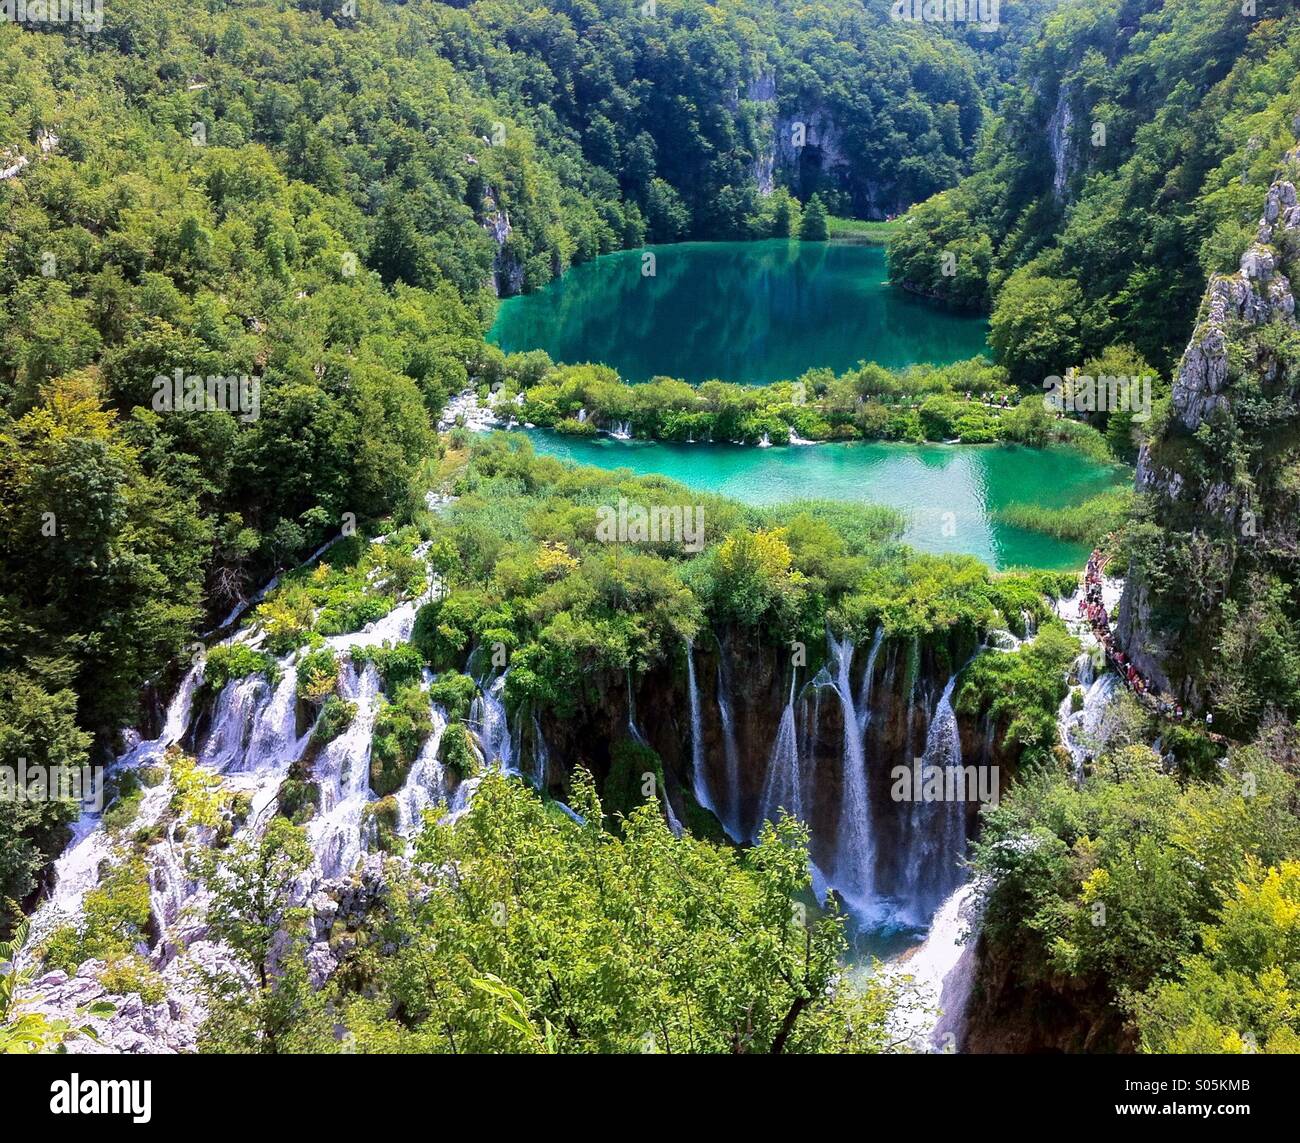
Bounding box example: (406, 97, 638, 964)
(1118, 148, 1300, 709)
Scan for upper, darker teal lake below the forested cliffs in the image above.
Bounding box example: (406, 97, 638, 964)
(488, 238, 987, 385)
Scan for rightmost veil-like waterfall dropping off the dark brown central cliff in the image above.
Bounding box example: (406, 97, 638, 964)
(906, 675, 966, 921)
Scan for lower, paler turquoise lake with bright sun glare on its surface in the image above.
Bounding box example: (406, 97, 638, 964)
(529, 429, 1132, 571)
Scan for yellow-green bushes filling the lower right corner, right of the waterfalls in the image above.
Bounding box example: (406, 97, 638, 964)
(975, 731, 1300, 1051)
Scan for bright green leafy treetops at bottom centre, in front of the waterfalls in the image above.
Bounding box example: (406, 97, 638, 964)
(202, 771, 906, 1053)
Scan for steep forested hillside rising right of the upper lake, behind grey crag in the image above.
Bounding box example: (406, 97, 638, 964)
(891, 0, 1300, 371)
